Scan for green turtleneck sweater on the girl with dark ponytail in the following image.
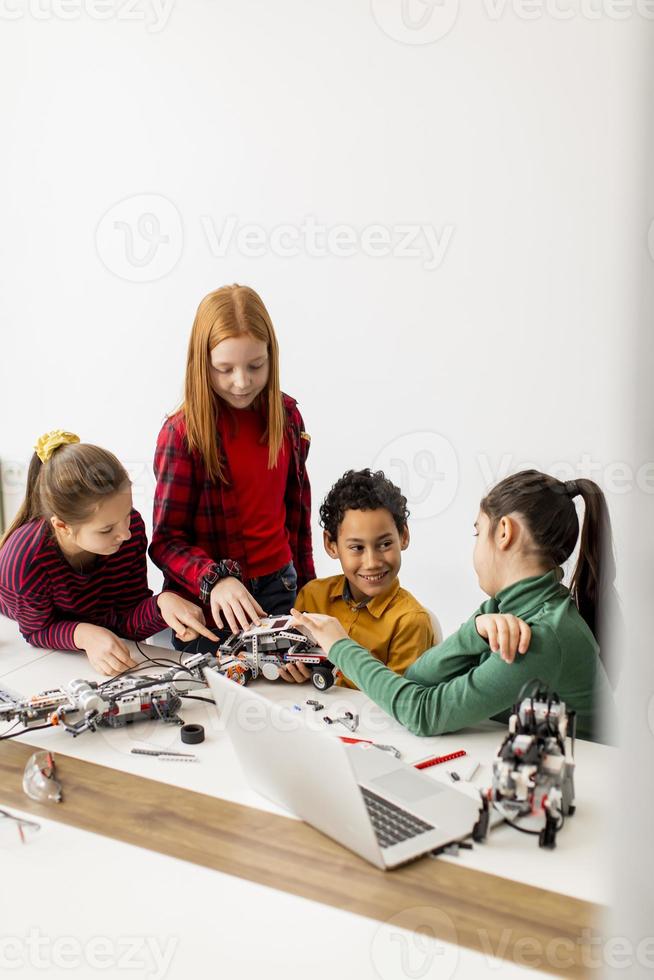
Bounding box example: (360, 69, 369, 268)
(329, 569, 612, 741)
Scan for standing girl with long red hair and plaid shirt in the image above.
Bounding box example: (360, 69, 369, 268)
(150, 285, 315, 648)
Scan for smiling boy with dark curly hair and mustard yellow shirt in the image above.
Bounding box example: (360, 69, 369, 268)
(282, 469, 436, 689)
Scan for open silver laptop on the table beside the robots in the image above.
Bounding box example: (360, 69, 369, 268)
(204, 670, 479, 868)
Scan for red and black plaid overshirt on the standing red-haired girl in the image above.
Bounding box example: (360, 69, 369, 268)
(150, 394, 316, 603)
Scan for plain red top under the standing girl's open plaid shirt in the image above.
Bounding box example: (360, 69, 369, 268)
(218, 406, 292, 578)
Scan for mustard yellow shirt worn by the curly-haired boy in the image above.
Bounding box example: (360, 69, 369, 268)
(295, 575, 434, 690)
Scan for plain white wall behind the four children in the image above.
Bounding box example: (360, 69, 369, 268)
(0, 0, 654, 632)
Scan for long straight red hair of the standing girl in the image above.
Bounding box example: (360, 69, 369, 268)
(180, 284, 285, 480)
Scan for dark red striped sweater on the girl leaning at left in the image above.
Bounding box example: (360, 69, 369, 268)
(0, 510, 166, 650)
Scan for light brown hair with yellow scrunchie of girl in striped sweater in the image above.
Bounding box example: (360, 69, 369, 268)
(0, 430, 130, 547)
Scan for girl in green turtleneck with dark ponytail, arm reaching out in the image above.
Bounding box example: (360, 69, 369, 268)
(295, 470, 613, 741)
